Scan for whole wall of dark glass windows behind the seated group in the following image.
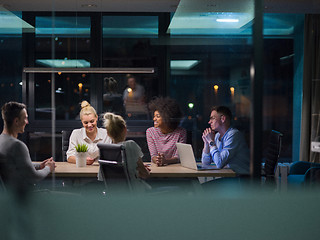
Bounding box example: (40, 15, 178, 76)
(1, 1, 303, 171)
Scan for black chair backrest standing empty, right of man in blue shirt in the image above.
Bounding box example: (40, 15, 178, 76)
(264, 130, 283, 176)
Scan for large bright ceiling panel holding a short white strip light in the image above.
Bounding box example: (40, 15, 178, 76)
(168, 0, 254, 35)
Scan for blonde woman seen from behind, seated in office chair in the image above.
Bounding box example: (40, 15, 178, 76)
(103, 112, 150, 190)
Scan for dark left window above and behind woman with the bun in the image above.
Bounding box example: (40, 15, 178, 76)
(34, 16, 93, 120)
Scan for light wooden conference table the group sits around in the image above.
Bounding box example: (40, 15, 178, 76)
(51, 162, 236, 178)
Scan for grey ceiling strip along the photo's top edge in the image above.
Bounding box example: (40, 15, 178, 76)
(0, 0, 320, 13)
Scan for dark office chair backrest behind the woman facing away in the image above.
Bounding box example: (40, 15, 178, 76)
(97, 143, 132, 195)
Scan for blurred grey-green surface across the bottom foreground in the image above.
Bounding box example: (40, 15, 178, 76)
(0, 184, 320, 240)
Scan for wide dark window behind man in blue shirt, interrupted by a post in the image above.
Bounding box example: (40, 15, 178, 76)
(169, 13, 303, 161)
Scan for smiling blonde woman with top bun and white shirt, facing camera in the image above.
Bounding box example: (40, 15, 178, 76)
(67, 101, 111, 165)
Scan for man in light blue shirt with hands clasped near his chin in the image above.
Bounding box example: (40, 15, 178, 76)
(201, 106, 250, 175)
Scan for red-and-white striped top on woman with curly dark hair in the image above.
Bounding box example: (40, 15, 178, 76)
(146, 127, 187, 159)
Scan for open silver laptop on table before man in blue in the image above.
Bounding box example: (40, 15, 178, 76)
(176, 143, 219, 170)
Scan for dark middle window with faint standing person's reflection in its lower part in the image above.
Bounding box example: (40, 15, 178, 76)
(103, 14, 160, 120)
